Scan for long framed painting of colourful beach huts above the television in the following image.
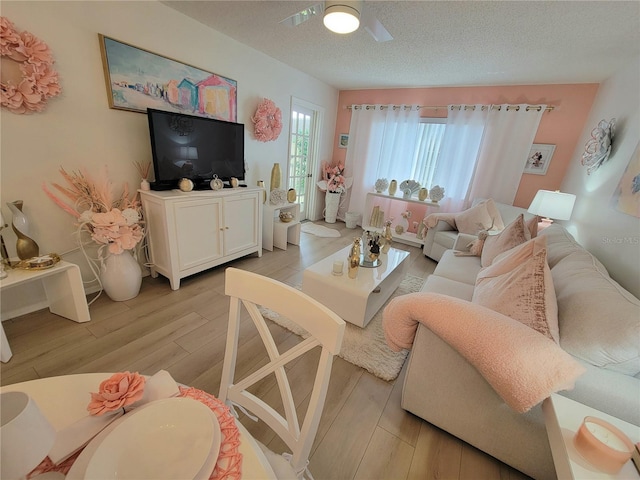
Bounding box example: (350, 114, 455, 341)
(98, 34, 238, 122)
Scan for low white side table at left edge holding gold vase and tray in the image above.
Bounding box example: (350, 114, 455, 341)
(0, 261, 91, 362)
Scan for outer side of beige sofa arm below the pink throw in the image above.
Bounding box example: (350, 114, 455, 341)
(401, 324, 556, 479)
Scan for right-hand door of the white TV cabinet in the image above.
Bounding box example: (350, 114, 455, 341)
(224, 193, 261, 255)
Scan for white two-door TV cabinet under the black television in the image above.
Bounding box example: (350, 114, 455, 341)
(139, 187, 263, 290)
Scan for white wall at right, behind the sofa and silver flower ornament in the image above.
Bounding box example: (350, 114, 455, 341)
(561, 57, 640, 297)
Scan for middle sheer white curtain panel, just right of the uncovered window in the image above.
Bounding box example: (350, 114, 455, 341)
(427, 105, 490, 212)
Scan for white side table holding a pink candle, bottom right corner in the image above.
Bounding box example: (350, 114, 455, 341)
(542, 394, 640, 480)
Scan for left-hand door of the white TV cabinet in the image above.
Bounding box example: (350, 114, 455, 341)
(174, 199, 223, 270)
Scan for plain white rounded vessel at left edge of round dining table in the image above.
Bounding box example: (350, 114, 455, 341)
(0, 392, 56, 480)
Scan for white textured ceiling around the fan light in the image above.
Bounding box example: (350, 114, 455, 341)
(162, 0, 640, 90)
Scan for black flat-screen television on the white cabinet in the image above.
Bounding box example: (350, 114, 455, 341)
(147, 109, 244, 189)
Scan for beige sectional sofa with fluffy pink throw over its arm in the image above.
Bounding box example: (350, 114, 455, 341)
(402, 215, 640, 479)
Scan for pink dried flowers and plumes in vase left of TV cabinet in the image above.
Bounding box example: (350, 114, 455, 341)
(42, 168, 144, 254)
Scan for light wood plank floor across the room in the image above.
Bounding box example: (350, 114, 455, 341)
(0, 222, 527, 480)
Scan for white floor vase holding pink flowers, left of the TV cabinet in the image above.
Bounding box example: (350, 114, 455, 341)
(100, 250, 142, 302)
